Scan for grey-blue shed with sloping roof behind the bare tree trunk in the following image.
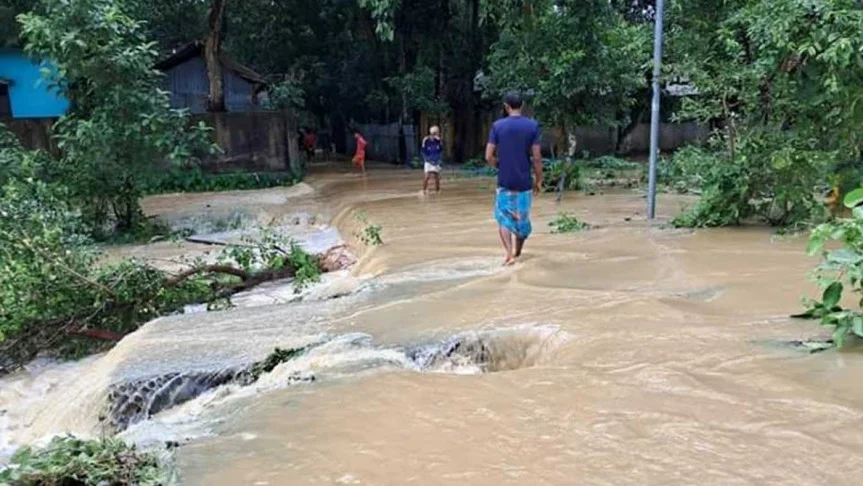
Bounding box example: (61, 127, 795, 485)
(156, 41, 267, 113)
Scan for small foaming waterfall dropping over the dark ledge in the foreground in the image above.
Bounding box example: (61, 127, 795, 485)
(3, 326, 567, 458)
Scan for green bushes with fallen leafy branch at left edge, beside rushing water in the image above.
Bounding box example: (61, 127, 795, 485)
(0, 196, 321, 372)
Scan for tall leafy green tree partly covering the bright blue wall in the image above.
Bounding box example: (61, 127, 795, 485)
(19, 0, 212, 235)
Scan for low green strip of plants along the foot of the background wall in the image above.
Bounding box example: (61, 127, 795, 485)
(142, 167, 295, 194)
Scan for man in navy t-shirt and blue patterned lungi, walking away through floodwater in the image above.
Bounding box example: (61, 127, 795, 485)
(485, 91, 542, 265)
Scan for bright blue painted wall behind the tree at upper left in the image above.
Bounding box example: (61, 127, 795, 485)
(0, 50, 69, 118)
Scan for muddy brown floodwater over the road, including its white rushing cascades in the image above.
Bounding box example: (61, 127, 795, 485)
(0, 166, 863, 485)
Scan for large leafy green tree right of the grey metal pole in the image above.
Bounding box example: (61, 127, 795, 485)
(669, 0, 863, 226)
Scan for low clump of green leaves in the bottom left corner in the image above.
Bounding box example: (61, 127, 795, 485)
(0, 436, 169, 486)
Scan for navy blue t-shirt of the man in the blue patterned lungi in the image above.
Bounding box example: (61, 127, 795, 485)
(488, 116, 540, 191)
